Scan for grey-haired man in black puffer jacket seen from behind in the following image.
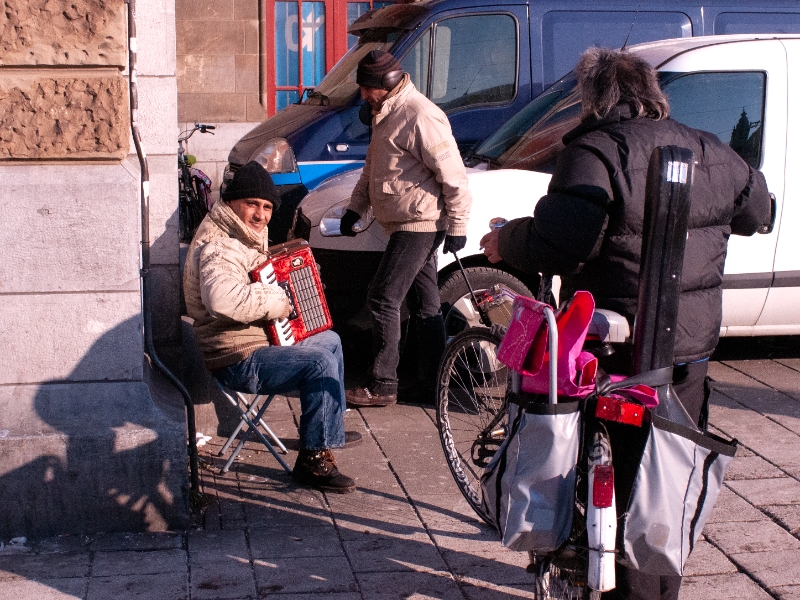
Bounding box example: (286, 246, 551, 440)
(481, 48, 770, 600)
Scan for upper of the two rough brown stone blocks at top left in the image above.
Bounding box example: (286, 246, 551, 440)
(0, 0, 128, 67)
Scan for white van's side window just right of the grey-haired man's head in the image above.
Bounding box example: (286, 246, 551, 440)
(664, 72, 766, 169)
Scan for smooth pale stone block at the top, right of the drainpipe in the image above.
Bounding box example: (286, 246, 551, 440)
(136, 0, 175, 77)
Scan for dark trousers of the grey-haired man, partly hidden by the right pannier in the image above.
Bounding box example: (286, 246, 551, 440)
(603, 360, 709, 600)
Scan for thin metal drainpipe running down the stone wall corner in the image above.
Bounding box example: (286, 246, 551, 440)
(125, 0, 200, 496)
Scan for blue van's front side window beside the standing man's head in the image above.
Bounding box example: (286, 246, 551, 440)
(426, 15, 518, 111)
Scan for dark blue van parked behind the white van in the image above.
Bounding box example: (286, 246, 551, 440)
(223, 0, 800, 243)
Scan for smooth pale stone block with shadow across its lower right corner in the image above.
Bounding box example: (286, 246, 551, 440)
(0, 290, 143, 384)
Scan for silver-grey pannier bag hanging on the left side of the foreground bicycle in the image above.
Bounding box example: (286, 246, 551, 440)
(481, 393, 581, 552)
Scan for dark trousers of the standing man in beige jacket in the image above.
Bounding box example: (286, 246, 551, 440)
(367, 231, 445, 395)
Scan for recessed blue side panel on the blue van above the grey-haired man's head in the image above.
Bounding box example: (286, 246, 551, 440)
(542, 10, 692, 85)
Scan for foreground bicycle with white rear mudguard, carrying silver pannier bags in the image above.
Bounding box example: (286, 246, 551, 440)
(436, 275, 627, 600)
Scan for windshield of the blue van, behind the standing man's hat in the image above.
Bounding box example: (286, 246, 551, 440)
(301, 28, 405, 106)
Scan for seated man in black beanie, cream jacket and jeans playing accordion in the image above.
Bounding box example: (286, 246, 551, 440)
(183, 161, 360, 493)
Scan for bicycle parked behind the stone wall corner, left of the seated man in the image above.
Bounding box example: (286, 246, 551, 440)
(178, 123, 215, 244)
